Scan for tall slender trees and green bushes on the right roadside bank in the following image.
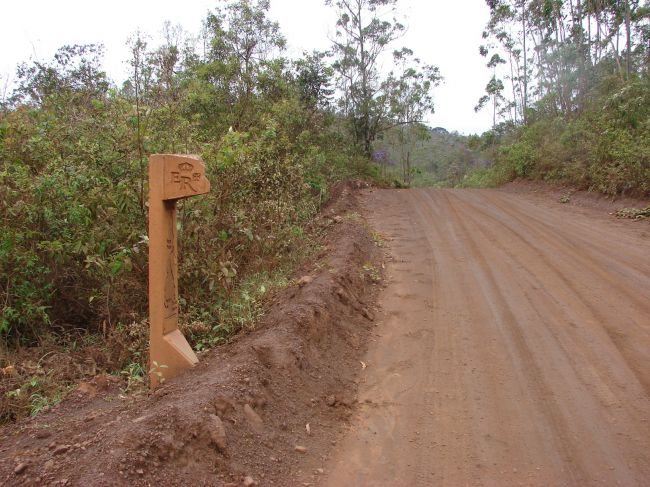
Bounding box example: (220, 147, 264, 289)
(462, 0, 650, 196)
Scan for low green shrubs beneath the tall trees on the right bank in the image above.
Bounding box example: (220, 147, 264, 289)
(463, 78, 650, 196)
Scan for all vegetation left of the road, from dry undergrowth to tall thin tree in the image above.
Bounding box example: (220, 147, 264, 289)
(0, 0, 440, 423)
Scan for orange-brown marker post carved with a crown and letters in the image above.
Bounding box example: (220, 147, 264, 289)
(149, 154, 210, 388)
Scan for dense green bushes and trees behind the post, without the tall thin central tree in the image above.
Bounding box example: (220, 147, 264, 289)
(0, 1, 365, 358)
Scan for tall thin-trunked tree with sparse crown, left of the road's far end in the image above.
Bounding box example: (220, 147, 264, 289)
(326, 0, 440, 157)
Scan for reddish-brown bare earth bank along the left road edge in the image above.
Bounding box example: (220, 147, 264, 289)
(0, 184, 381, 486)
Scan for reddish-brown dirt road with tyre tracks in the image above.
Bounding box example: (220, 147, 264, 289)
(325, 190, 650, 486)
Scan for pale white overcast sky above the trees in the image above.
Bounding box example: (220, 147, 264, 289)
(0, 0, 491, 133)
